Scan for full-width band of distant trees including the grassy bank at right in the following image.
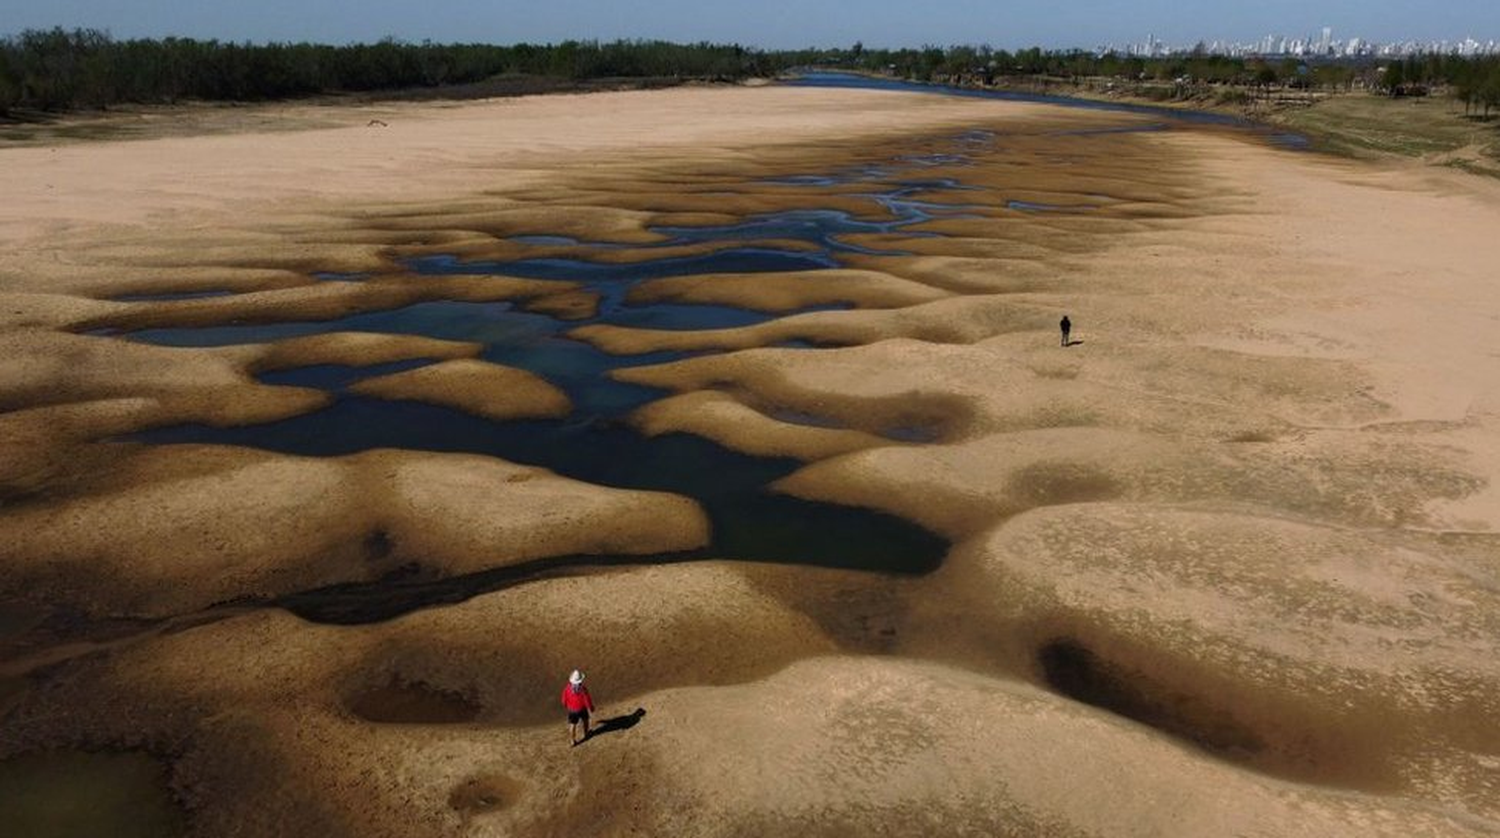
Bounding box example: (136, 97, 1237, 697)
(0, 28, 1500, 169)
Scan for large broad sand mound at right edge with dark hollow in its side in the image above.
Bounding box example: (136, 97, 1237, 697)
(914, 504, 1500, 817)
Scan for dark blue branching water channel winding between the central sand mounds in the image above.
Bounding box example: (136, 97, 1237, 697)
(122, 176, 975, 622)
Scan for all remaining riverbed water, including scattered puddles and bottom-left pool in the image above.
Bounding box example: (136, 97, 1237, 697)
(0, 76, 1320, 835)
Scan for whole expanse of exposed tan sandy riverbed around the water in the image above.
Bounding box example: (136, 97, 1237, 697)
(0, 87, 1500, 837)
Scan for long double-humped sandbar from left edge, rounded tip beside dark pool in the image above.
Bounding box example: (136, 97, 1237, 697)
(0, 445, 708, 616)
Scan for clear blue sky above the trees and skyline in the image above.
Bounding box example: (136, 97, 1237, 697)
(0, 0, 1500, 48)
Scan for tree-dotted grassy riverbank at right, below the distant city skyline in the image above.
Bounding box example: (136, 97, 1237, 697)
(821, 43, 1500, 174)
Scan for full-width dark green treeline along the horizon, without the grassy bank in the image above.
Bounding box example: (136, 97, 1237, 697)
(0, 28, 1500, 115)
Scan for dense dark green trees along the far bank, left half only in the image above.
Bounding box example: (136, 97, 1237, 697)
(0, 28, 785, 114)
